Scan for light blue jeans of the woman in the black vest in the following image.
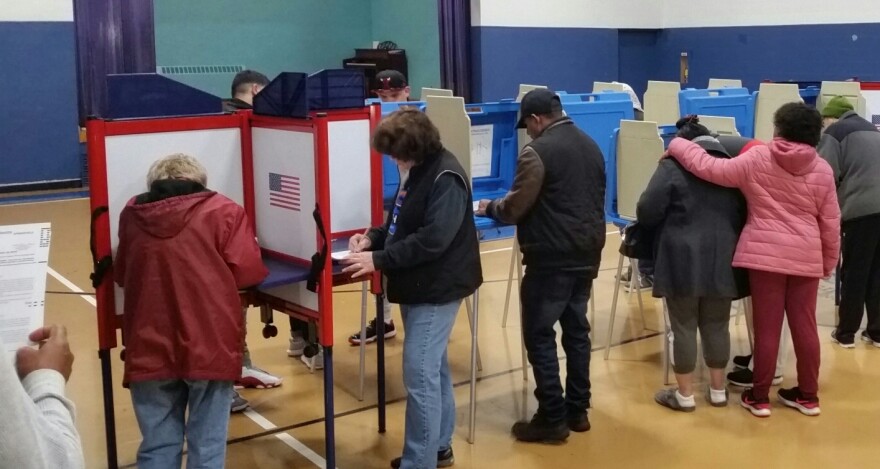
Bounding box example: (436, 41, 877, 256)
(400, 300, 461, 469)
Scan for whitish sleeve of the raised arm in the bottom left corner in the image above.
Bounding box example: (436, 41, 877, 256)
(0, 343, 85, 469)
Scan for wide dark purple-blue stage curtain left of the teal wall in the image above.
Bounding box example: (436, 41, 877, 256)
(73, 0, 156, 123)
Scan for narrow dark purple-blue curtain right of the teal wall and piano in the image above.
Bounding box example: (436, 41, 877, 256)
(437, 0, 471, 102)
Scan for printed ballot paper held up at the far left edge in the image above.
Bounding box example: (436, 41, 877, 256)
(0, 223, 52, 352)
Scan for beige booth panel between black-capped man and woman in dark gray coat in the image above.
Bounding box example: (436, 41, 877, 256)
(617, 120, 663, 220)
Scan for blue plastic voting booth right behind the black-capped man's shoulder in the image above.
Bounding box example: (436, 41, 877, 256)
(557, 91, 635, 166)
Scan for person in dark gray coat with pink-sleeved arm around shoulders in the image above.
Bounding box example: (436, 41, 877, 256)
(636, 116, 748, 412)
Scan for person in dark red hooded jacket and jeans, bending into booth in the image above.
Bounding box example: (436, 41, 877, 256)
(113, 154, 268, 469)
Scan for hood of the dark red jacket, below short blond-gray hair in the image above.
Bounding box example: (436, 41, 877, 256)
(128, 192, 217, 239)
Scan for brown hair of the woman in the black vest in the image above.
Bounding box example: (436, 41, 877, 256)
(373, 109, 443, 164)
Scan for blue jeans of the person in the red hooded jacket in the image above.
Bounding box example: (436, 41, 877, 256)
(130, 380, 232, 469)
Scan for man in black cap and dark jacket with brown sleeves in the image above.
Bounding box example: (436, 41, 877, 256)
(477, 89, 605, 442)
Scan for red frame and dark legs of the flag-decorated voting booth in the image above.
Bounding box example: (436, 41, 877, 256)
(86, 105, 385, 468)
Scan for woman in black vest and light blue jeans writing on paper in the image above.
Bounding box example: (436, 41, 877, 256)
(343, 109, 483, 468)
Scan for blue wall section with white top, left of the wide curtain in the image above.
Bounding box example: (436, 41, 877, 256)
(0, 0, 82, 191)
